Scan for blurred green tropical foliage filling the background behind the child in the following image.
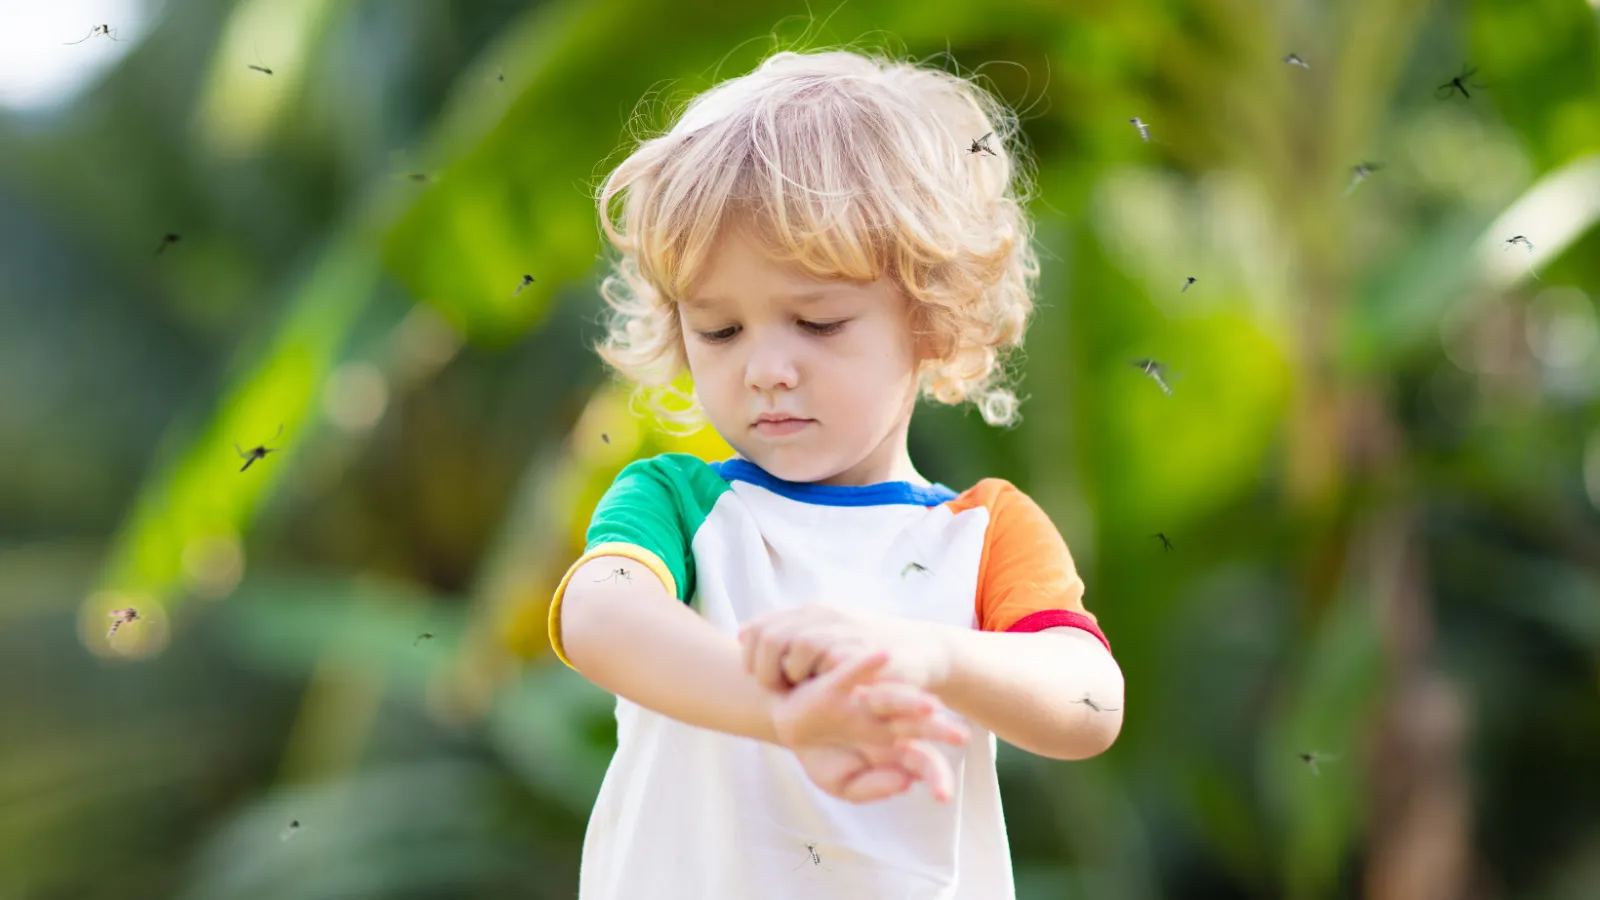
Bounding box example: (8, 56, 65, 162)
(0, 0, 1600, 900)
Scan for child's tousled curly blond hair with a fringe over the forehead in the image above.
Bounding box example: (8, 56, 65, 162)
(595, 43, 1038, 426)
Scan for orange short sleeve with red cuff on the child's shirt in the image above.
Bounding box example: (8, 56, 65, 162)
(949, 479, 1110, 650)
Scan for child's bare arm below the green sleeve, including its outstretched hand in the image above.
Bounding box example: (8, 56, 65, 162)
(558, 556, 966, 749)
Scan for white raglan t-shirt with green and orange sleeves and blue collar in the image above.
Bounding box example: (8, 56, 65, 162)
(550, 453, 1110, 900)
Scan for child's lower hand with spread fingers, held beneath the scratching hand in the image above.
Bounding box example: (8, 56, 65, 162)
(773, 653, 968, 749)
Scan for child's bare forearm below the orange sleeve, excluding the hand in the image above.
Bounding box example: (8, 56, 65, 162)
(930, 628, 1123, 759)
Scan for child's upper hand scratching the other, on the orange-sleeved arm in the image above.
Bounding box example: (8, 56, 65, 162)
(739, 604, 950, 690)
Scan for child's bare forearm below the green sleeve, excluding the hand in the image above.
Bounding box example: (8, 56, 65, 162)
(560, 557, 778, 743)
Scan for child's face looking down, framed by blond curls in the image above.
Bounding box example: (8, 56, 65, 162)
(680, 226, 917, 484)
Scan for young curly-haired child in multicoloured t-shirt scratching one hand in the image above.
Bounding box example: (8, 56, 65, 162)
(550, 51, 1123, 900)
